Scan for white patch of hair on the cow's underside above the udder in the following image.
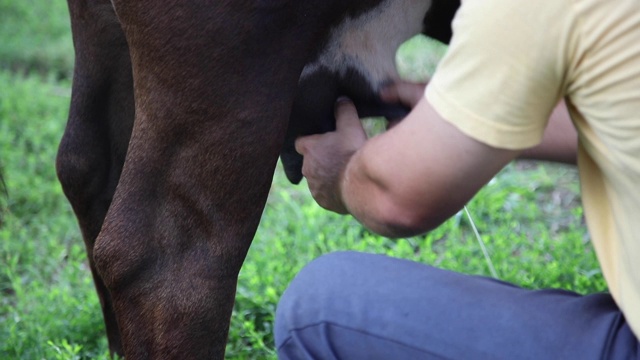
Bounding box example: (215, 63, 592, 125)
(300, 0, 431, 90)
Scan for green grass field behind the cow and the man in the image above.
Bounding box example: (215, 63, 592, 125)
(0, 0, 606, 359)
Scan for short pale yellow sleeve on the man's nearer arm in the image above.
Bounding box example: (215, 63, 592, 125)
(425, 0, 573, 150)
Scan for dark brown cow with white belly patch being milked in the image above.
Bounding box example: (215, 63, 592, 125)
(57, 0, 459, 359)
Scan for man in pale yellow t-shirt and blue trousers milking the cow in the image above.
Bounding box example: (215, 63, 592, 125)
(275, 0, 640, 359)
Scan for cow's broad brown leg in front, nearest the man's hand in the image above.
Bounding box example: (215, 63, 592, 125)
(94, 1, 330, 359)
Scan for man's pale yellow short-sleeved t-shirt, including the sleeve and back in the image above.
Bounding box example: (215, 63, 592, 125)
(426, 0, 640, 337)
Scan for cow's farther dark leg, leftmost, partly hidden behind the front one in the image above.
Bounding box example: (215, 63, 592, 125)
(57, 0, 134, 355)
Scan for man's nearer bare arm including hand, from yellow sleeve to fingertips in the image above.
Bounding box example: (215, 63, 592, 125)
(296, 97, 518, 237)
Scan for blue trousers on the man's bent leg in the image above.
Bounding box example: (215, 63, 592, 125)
(275, 252, 640, 360)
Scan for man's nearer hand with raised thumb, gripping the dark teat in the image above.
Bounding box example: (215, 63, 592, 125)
(296, 98, 367, 214)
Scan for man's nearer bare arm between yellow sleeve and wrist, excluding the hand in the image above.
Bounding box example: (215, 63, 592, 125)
(340, 98, 518, 237)
